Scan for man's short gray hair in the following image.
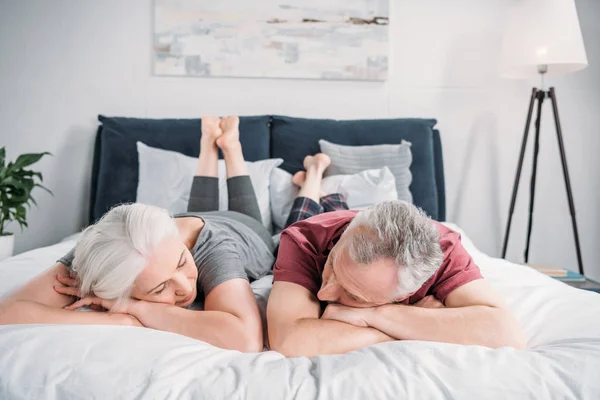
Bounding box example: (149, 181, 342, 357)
(343, 200, 443, 298)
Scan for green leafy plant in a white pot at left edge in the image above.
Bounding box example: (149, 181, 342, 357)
(0, 147, 52, 260)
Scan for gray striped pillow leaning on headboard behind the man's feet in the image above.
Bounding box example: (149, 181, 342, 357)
(319, 139, 413, 203)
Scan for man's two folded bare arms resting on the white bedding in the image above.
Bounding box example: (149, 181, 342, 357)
(267, 279, 524, 357)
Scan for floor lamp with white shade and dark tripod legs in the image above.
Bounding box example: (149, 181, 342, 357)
(502, 0, 588, 274)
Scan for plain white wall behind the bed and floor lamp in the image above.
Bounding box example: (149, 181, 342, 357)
(0, 0, 600, 280)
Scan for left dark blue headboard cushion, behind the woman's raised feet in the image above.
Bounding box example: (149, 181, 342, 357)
(89, 115, 271, 222)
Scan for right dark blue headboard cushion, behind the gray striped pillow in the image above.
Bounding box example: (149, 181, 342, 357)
(270, 115, 446, 220)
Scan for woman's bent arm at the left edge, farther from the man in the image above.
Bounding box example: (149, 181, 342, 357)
(0, 263, 141, 326)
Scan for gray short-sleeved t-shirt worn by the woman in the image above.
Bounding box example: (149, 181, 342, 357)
(58, 211, 275, 297)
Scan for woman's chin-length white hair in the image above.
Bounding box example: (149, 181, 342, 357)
(72, 203, 178, 303)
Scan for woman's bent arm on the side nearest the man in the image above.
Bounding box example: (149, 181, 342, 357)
(128, 279, 263, 352)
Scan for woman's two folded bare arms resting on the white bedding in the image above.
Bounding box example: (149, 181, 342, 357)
(0, 263, 263, 352)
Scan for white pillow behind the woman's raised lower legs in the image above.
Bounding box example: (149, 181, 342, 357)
(136, 142, 283, 232)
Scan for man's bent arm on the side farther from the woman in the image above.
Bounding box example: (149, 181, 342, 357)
(334, 279, 525, 349)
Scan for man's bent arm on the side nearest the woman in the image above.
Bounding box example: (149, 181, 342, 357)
(267, 281, 392, 357)
